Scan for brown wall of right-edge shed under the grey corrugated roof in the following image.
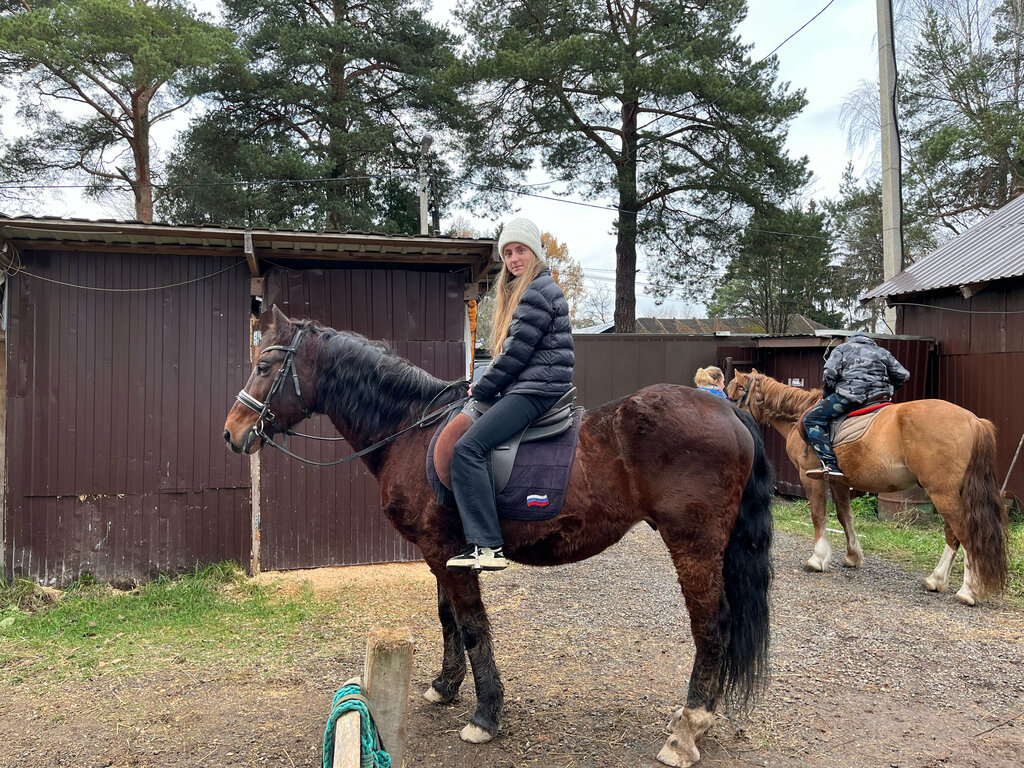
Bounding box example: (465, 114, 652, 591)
(898, 279, 1024, 497)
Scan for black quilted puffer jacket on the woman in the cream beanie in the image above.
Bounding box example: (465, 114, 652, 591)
(473, 269, 575, 400)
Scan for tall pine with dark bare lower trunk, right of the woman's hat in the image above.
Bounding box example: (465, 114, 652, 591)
(453, 0, 806, 332)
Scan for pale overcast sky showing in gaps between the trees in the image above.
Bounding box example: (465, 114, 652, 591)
(2, 0, 878, 316)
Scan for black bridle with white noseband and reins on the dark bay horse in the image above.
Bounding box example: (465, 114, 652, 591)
(234, 328, 469, 467)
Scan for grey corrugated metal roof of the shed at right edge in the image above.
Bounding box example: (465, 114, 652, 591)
(860, 195, 1024, 301)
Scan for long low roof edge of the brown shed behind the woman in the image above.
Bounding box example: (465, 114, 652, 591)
(0, 214, 497, 267)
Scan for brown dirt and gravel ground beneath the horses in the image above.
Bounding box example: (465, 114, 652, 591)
(0, 526, 1024, 768)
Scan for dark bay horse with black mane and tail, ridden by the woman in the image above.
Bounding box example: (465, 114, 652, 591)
(224, 307, 772, 766)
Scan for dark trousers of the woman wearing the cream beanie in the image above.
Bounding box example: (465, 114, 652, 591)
(452, 394, 558, 547)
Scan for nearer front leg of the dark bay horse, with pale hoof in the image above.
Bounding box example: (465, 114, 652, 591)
(431, 564, 505, 744)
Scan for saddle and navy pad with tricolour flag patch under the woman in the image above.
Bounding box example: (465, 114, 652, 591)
(427, 387, 583, 519)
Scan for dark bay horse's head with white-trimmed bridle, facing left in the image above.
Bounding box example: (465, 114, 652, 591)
(224, 305, 315, 454)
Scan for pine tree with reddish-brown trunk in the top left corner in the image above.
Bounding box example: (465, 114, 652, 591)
(0, 0, 232, 221)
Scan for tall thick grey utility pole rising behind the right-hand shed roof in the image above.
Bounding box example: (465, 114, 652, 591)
(874, 0, 903, 333)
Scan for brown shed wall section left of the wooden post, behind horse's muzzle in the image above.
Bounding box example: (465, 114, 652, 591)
(6, 250, 250, 585)
